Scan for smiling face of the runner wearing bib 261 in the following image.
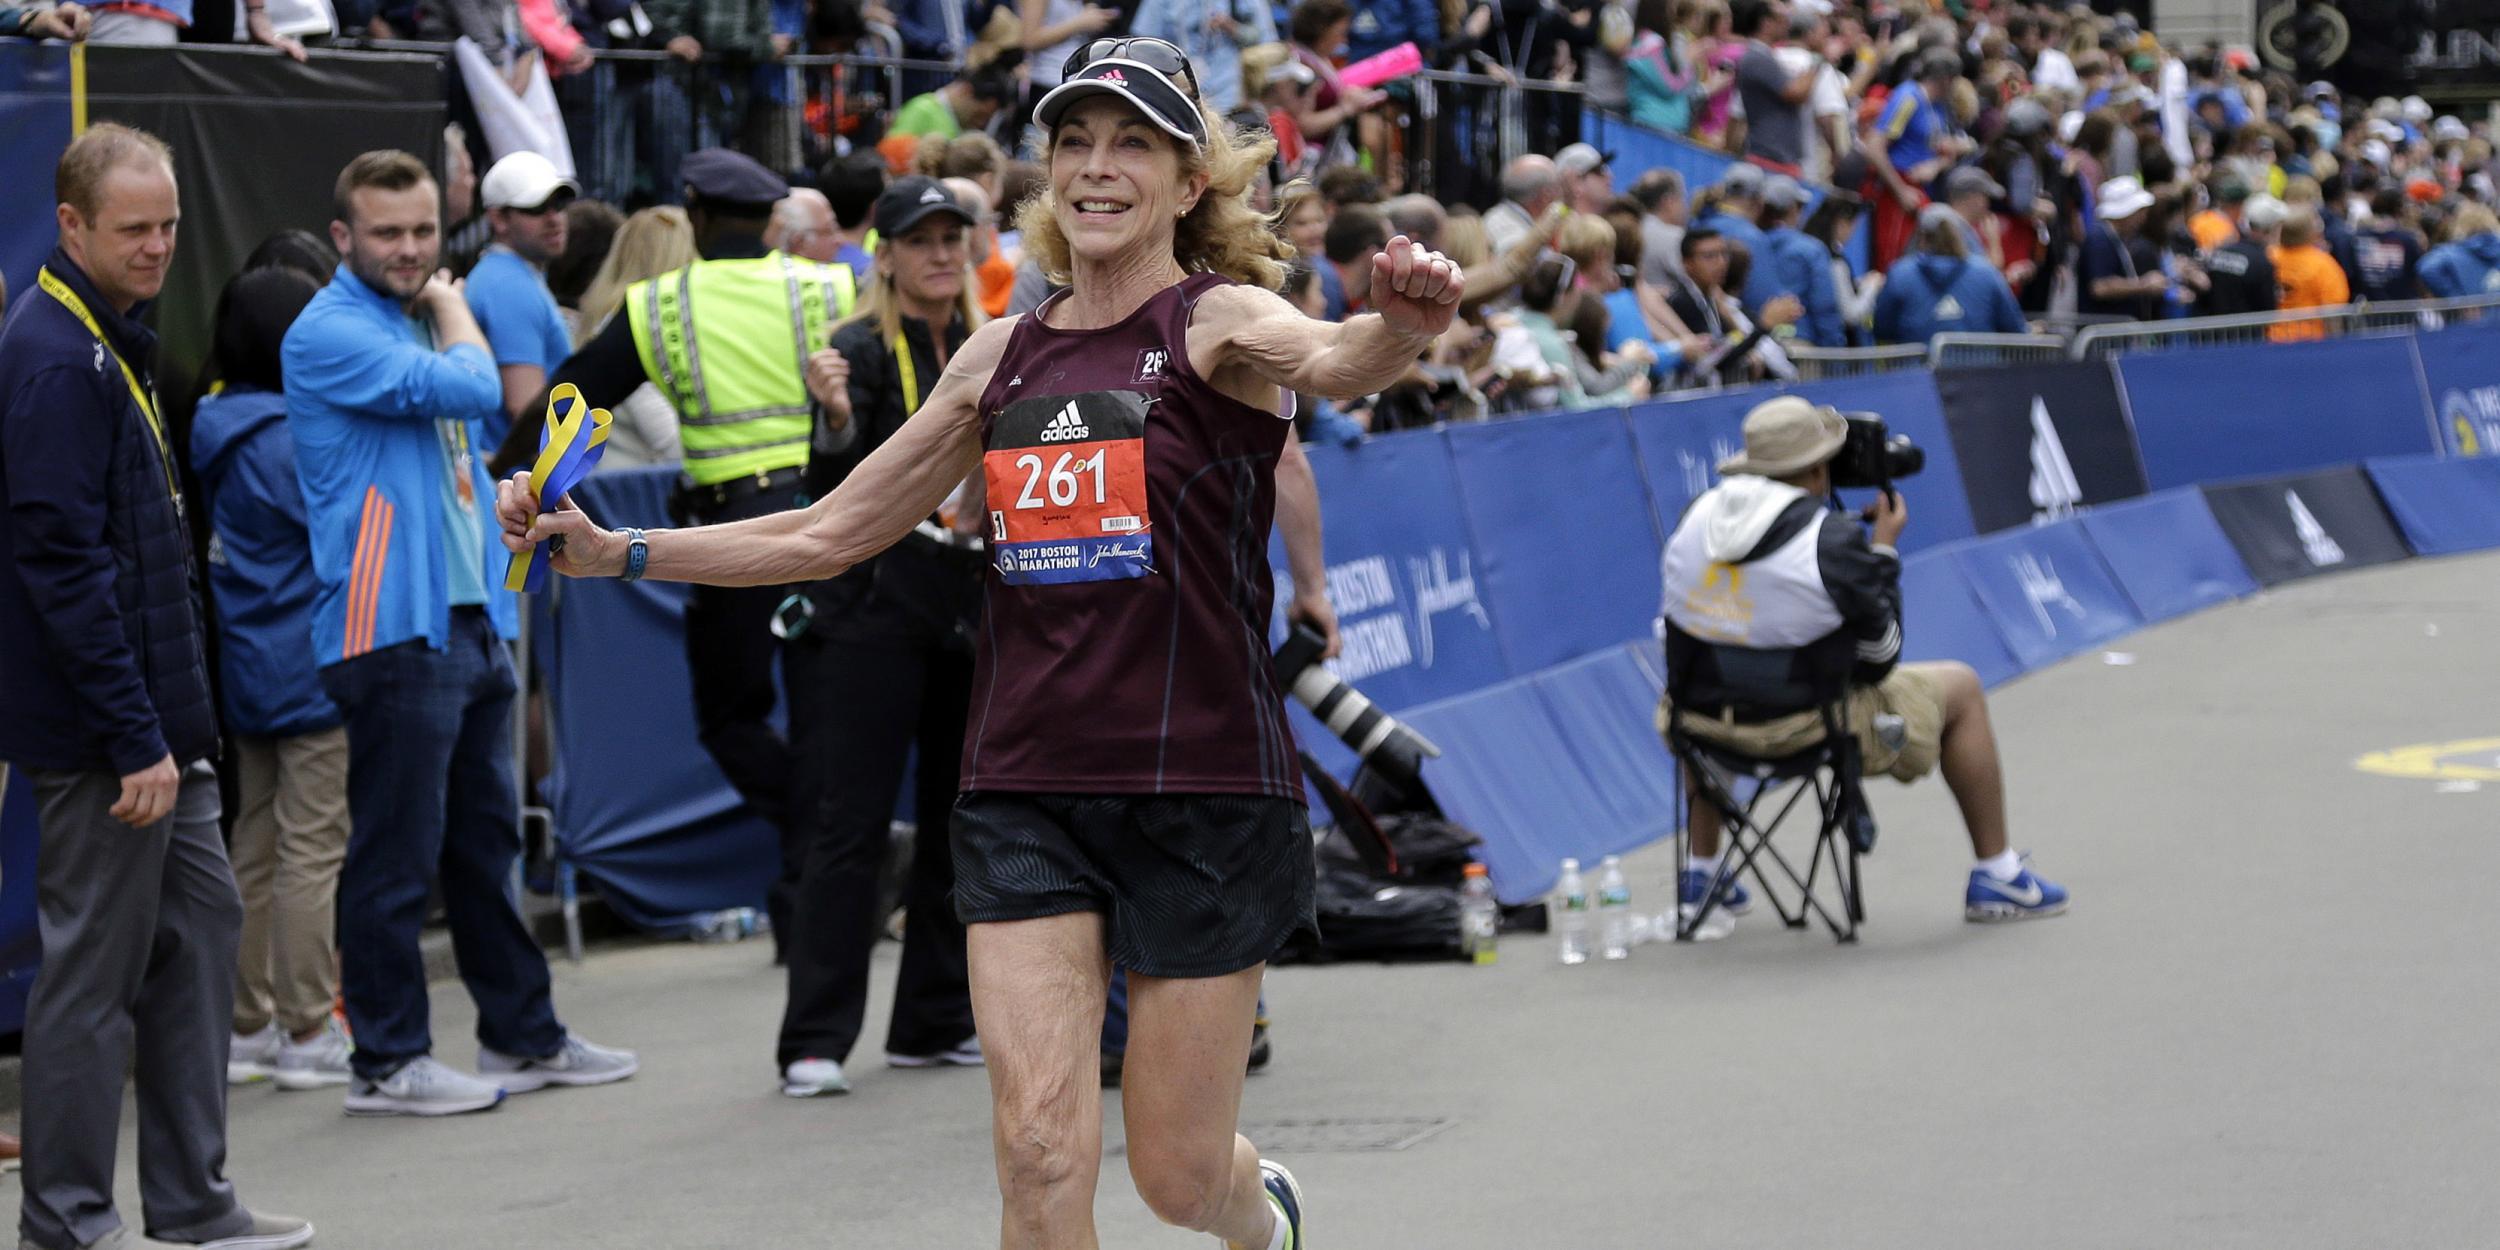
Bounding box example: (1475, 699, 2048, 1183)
(1050, 95, 1208, 263)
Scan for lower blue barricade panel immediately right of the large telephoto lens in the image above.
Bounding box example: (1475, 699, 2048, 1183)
(1408, 680, 1610, 903)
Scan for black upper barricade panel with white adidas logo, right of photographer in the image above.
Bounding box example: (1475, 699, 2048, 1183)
(1935, 360, 2145, 535)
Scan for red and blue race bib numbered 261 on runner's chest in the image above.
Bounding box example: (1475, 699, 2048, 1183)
(983, 390, 1155, 585)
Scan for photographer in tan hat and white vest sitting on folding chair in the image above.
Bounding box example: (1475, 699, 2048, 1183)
(1660, 398, 2068, 920)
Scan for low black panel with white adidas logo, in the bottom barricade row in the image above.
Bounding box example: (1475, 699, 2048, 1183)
(2205, 465, 2413, 585)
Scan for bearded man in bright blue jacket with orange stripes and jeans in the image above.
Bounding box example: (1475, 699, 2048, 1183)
(283, 153, 635, 1115)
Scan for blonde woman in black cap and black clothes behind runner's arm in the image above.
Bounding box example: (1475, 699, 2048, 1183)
(775, 178, 988, 1098)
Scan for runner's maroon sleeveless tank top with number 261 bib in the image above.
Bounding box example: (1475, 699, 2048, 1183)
(963, 275, 1300, 798)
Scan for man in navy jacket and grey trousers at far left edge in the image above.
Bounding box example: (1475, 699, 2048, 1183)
(0, 125, 313, 1250)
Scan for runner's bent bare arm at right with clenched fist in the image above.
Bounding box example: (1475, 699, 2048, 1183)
(1190, 235, 1468, 400)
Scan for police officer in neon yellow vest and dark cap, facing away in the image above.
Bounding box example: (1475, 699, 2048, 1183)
(512, 148, 855, 885)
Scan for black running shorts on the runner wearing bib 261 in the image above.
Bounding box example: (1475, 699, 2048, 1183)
(953, 790, 1318, 978)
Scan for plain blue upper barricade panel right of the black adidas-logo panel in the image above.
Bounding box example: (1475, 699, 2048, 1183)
(2120, 338, 2435, 490)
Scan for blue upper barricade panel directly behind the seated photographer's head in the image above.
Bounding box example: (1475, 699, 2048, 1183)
(1630, 370, 1978, 552)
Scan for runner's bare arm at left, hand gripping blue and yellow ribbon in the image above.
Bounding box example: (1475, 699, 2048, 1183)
(495, 318, 1015, 585)
